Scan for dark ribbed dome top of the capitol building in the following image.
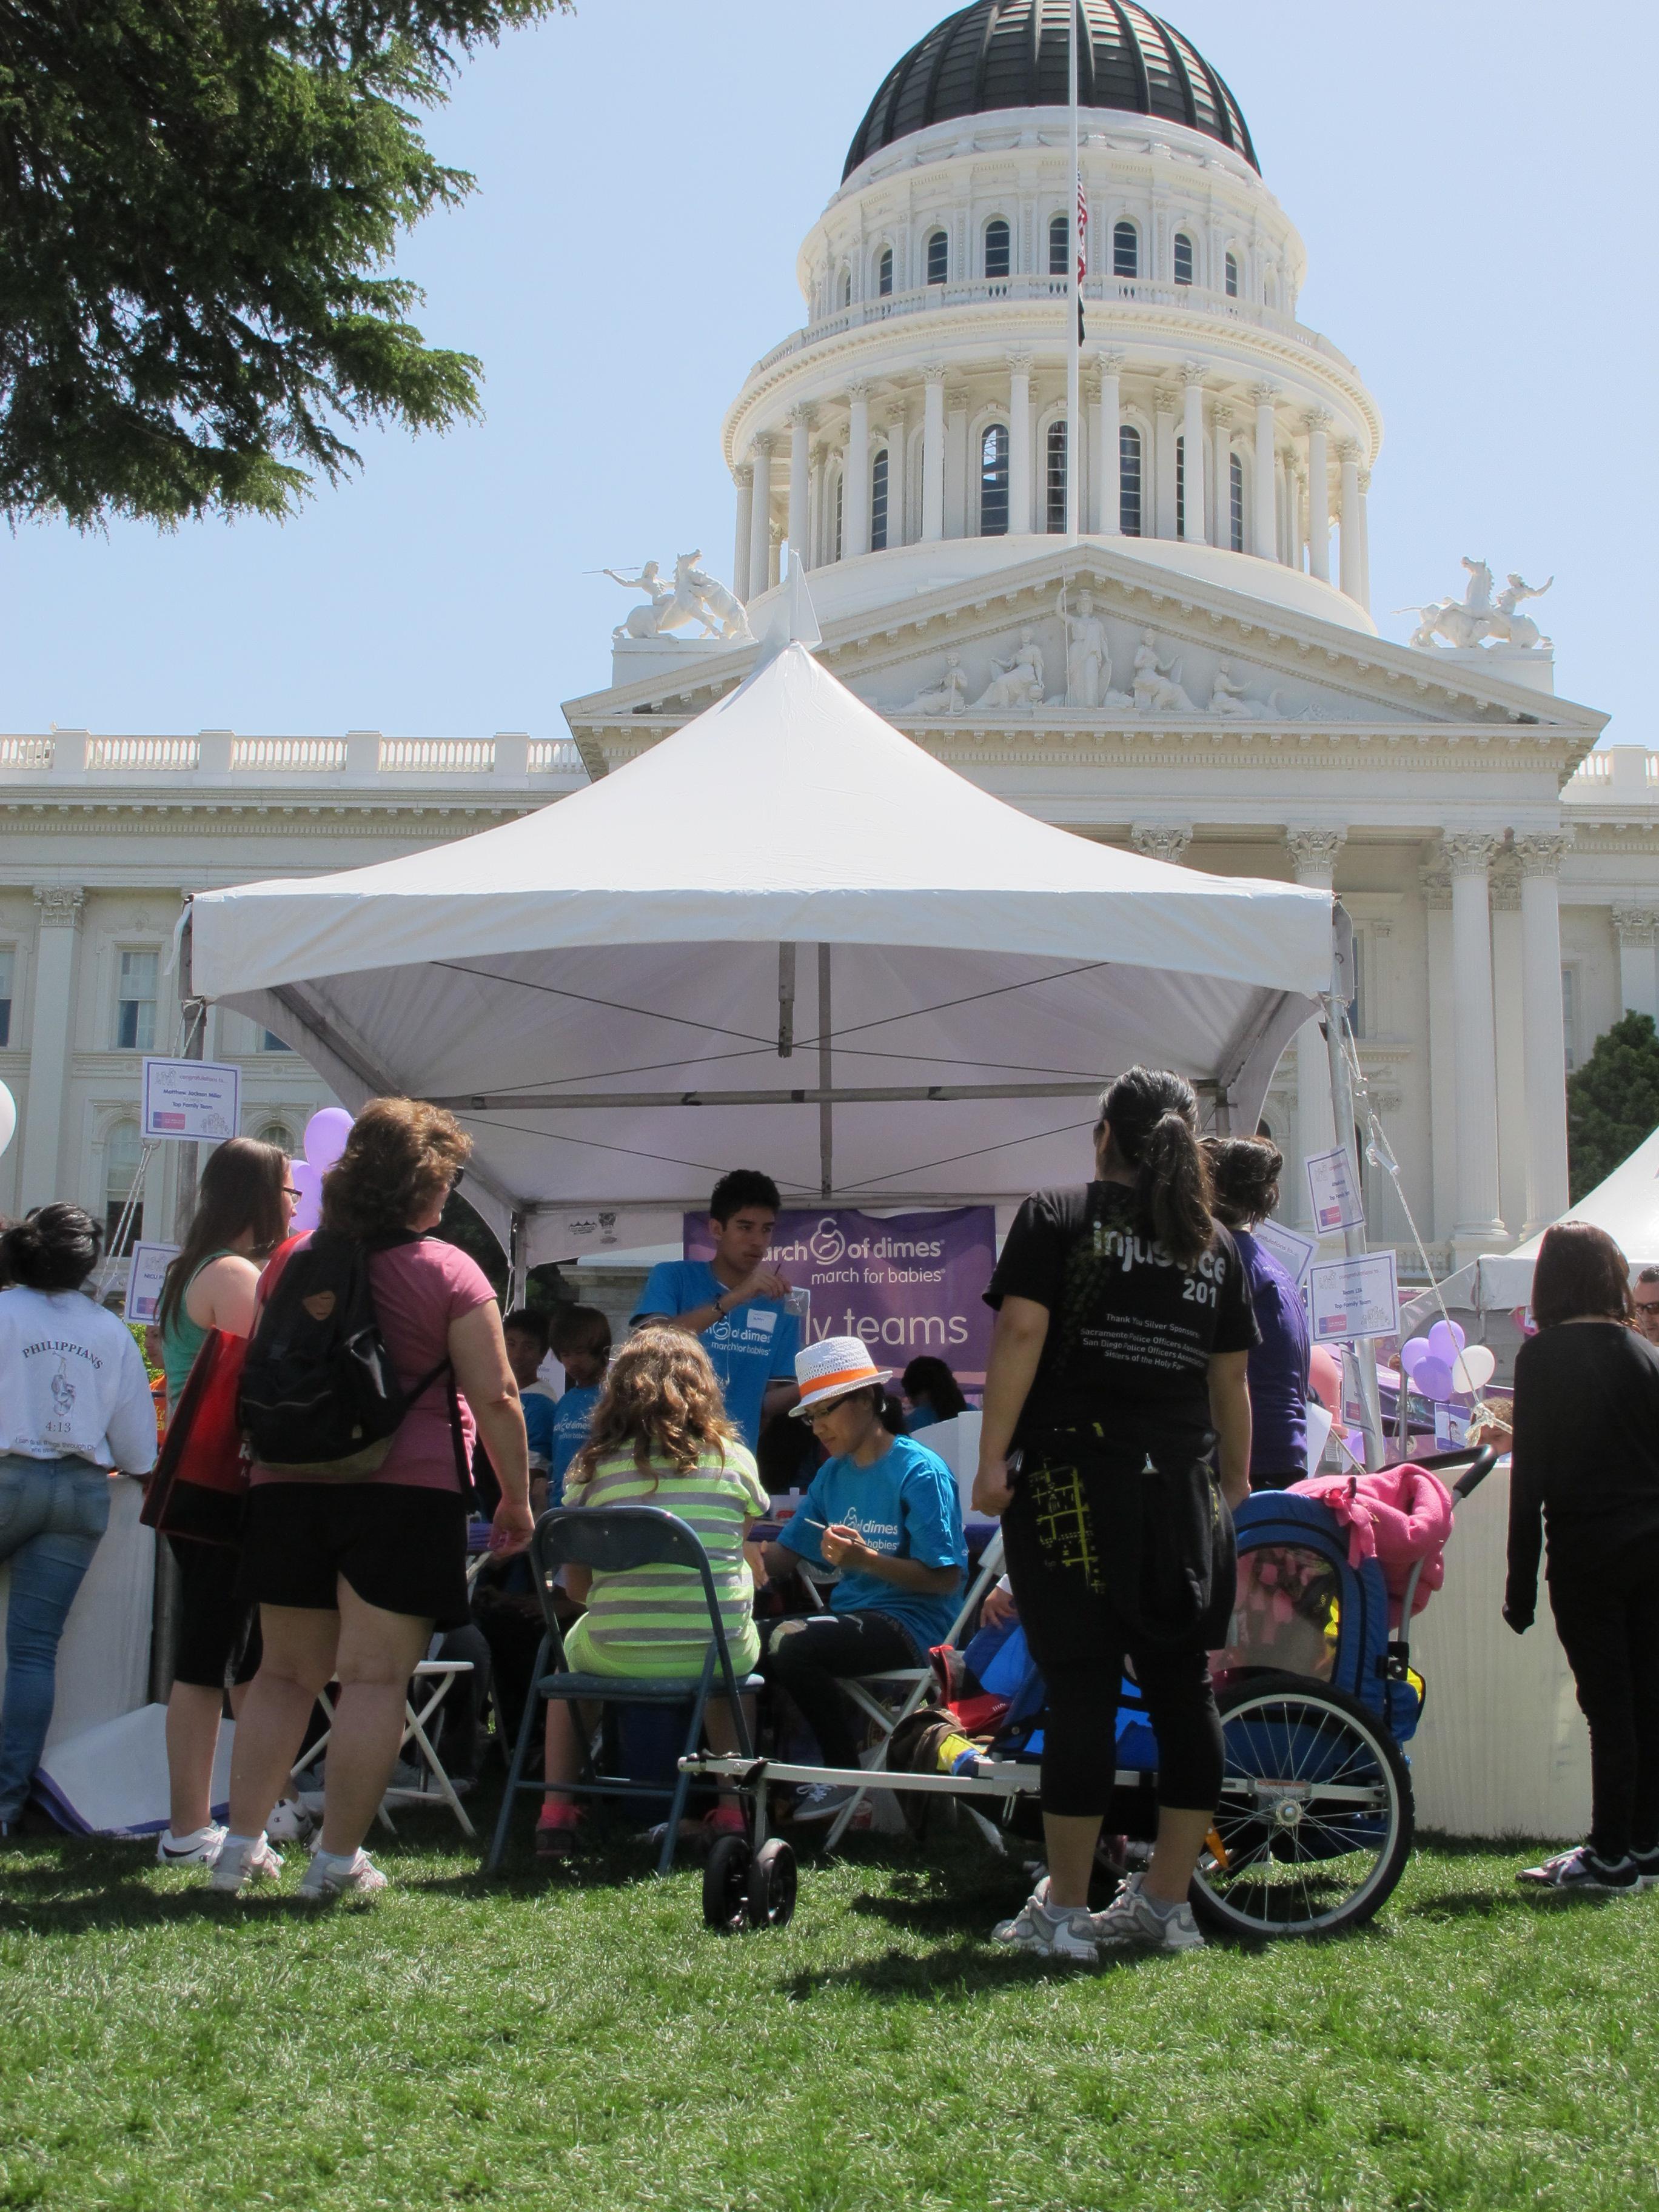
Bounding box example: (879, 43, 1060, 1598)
(840, 0, 1261, 181)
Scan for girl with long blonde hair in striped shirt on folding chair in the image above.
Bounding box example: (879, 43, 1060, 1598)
(535, 1327, 768, 1858)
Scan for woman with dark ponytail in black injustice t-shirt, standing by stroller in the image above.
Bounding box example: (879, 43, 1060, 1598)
(973, 1068, 1256, 1962)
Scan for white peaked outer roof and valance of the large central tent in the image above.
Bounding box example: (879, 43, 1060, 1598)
(195, 644, 1332, 996)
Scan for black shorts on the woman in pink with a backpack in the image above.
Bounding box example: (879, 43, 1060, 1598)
(241, 1482, 469, 1628)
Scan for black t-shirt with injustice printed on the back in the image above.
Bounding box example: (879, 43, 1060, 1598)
(984, 1184, 1261, 1453)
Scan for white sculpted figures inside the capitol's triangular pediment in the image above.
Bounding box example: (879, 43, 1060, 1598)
(891, 591, 1287, 721)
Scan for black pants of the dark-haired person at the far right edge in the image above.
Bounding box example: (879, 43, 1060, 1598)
(1549, 1544, 1659, 1860)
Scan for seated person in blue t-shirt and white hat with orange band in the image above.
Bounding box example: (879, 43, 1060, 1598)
(761, 1336, 967, 1820)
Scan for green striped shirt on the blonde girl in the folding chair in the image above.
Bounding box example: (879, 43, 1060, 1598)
(564, 1442, 770, 1677)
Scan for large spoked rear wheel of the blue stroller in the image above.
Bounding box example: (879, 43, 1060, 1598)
(1192, 1675, 1411, 1938)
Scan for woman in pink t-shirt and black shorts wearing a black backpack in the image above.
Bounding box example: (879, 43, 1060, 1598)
(212, 1099, 531, 1898)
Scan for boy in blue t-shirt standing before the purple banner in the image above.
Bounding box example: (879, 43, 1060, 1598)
(632, 1168, 801, 1451)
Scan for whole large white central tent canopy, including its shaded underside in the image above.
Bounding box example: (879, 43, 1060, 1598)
(192, 644, 1332, 1265)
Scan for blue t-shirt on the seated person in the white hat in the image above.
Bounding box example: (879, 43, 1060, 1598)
(779, 1436, 967, 1652)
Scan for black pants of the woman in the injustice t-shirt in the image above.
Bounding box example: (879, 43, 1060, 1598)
(1002, 1453, 1221, 1818)
